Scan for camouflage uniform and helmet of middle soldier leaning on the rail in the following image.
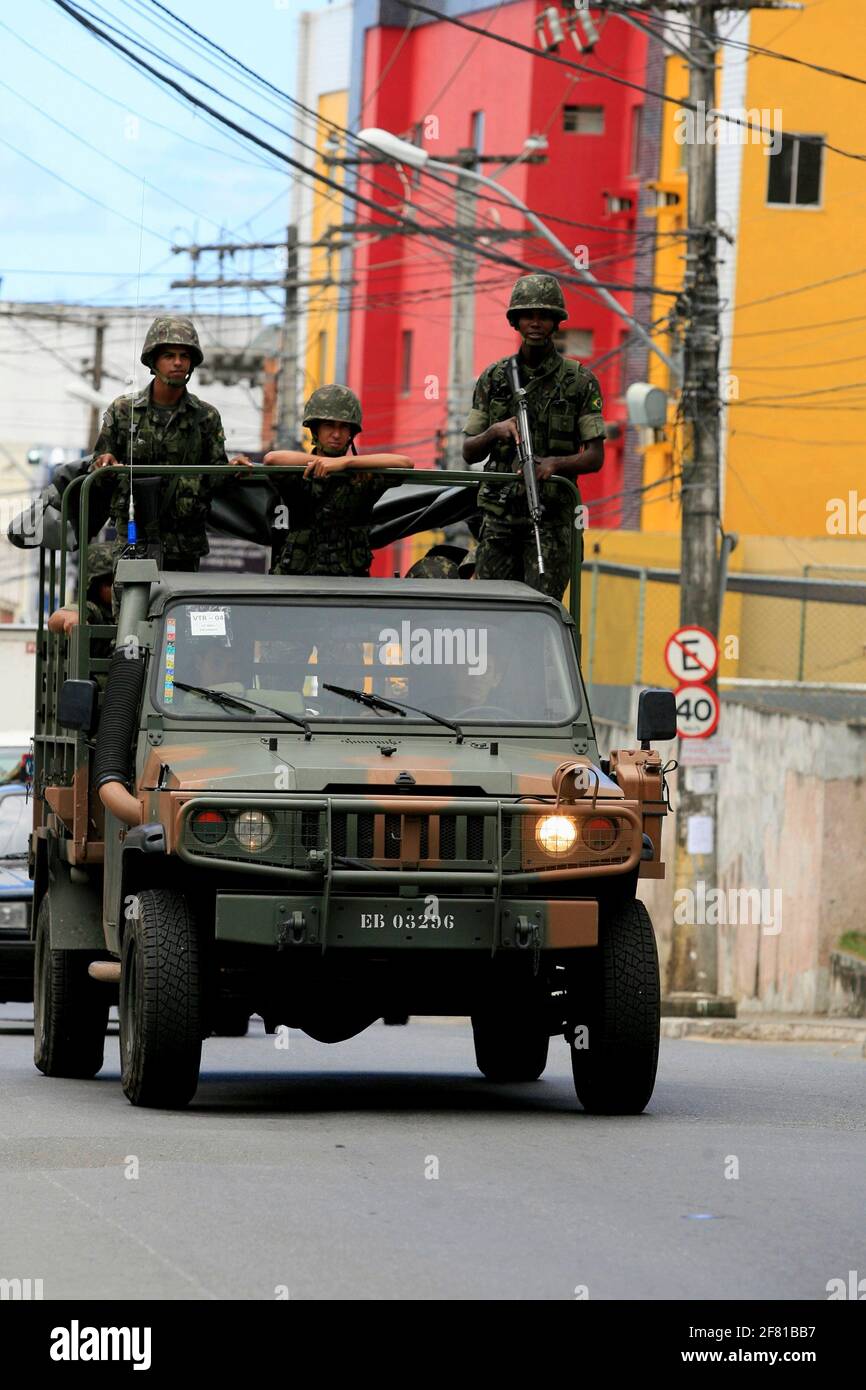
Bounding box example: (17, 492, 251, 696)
(271, 385, 402, 577)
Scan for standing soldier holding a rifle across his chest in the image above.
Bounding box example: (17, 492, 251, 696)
(463, 275, 605, 599)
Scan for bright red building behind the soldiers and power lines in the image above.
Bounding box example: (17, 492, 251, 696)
(341, 0, 646, 558)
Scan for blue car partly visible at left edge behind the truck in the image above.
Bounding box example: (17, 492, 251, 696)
(0, 783, 33, 1004)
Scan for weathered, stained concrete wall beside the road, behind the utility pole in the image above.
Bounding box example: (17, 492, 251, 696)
(596, 692, 866, 1013)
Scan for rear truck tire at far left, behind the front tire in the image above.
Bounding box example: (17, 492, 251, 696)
(33, 892, 111, 1080)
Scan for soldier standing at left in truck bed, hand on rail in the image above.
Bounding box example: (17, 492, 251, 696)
(90, 316, 250, 571)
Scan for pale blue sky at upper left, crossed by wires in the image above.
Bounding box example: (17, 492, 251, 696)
(0, 0, 335, 313)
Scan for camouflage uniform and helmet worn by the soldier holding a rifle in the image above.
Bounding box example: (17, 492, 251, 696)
(464, 275, 605, 599)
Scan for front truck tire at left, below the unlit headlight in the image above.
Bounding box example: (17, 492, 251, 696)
(120, 888, 202, 1109)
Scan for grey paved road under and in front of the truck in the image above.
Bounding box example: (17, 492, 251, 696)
(0, 1005, 866, 1300)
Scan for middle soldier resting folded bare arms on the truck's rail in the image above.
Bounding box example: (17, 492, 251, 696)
(264, 385, 413, 577)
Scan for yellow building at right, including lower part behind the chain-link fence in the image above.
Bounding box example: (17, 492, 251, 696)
(581, 0, 866, 684)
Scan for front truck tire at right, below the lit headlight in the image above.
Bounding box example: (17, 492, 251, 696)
(569, 901, 662, 1115)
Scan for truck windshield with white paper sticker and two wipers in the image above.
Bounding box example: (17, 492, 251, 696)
(154, 600, 581, 724)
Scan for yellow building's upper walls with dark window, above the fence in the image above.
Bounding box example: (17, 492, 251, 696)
(642, 0, 866, 544)
